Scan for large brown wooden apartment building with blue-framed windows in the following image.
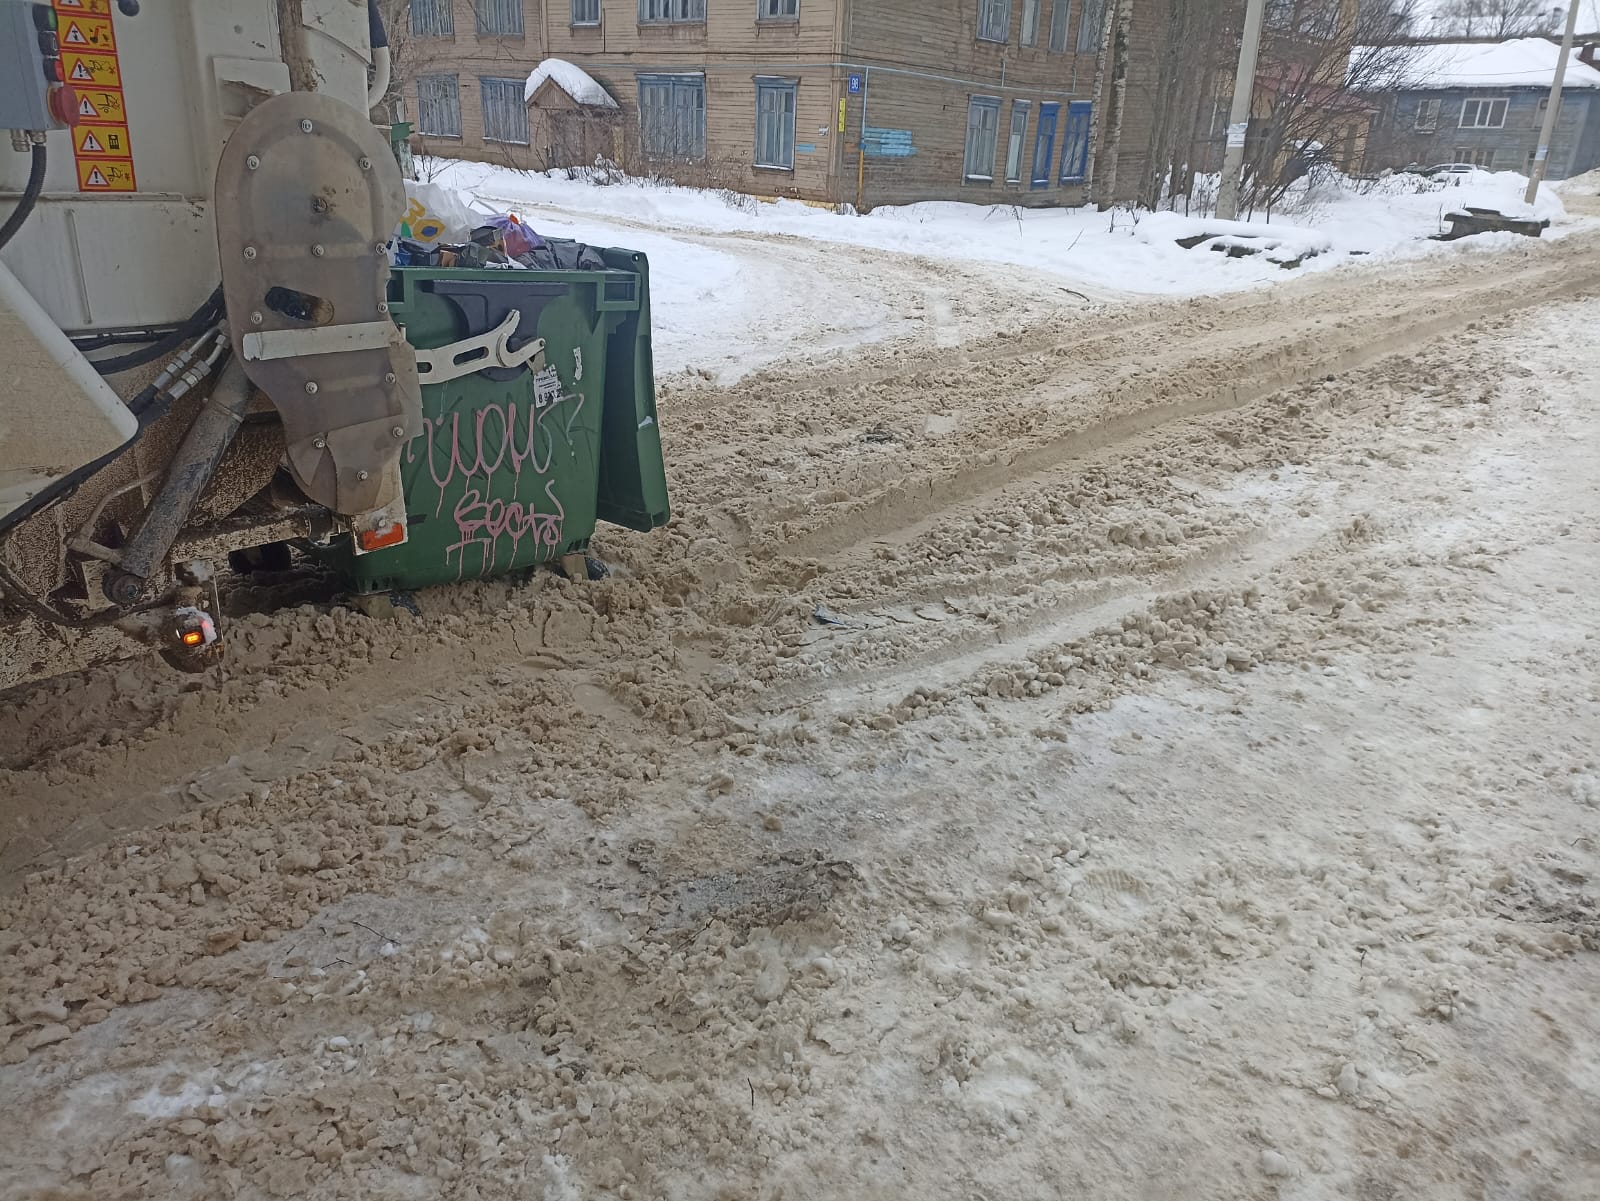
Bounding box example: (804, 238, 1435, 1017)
(402, 0, 1149, 206)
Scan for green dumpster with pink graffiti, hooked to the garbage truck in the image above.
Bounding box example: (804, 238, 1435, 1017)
(330, 249, 669, 592)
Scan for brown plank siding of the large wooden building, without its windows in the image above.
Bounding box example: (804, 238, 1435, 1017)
(408, 0, 1163, 205)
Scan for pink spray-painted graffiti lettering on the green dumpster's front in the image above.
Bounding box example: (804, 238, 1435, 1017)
(406, 382, 584, 579)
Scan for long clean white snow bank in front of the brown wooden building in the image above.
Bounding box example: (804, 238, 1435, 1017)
(421, 160, 1582, 326)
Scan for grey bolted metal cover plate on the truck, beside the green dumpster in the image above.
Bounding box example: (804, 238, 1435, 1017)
(216, 91, 421, 517)
